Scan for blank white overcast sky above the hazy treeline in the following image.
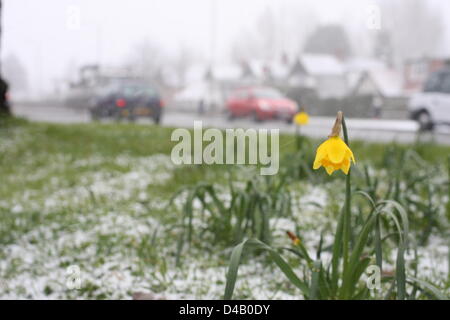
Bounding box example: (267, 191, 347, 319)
(2, 0, 450, 95)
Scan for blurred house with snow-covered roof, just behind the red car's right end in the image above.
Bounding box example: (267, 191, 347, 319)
(288, 54, 348, 99)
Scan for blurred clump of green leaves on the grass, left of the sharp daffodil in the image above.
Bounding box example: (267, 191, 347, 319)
(171, 171, 291, 262)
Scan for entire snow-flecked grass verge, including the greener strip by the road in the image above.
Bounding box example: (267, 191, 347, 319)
(0, 119, 450, 299)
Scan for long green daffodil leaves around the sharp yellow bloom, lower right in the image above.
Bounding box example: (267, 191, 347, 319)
(224, 120, 450, 300)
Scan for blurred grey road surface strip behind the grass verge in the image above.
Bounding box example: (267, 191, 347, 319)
(9, 104, 450, 145)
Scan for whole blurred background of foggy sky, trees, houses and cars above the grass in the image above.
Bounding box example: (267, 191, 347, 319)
(1, 0, 450, 142)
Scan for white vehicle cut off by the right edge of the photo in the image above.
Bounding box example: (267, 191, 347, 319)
(408, 67, 450, 130)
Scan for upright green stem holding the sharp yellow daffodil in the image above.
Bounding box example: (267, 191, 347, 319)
(342, 117, 351, 292)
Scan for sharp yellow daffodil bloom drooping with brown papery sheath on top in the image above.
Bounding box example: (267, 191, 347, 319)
(313, 113, 355, 175)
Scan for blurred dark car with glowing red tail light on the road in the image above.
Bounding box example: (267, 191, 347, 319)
(89, 81, 164, 123)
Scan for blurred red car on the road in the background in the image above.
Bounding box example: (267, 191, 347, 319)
(227, 87, 298, 122)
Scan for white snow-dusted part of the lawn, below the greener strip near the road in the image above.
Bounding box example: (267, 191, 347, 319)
(0, 121, 449, 299)
